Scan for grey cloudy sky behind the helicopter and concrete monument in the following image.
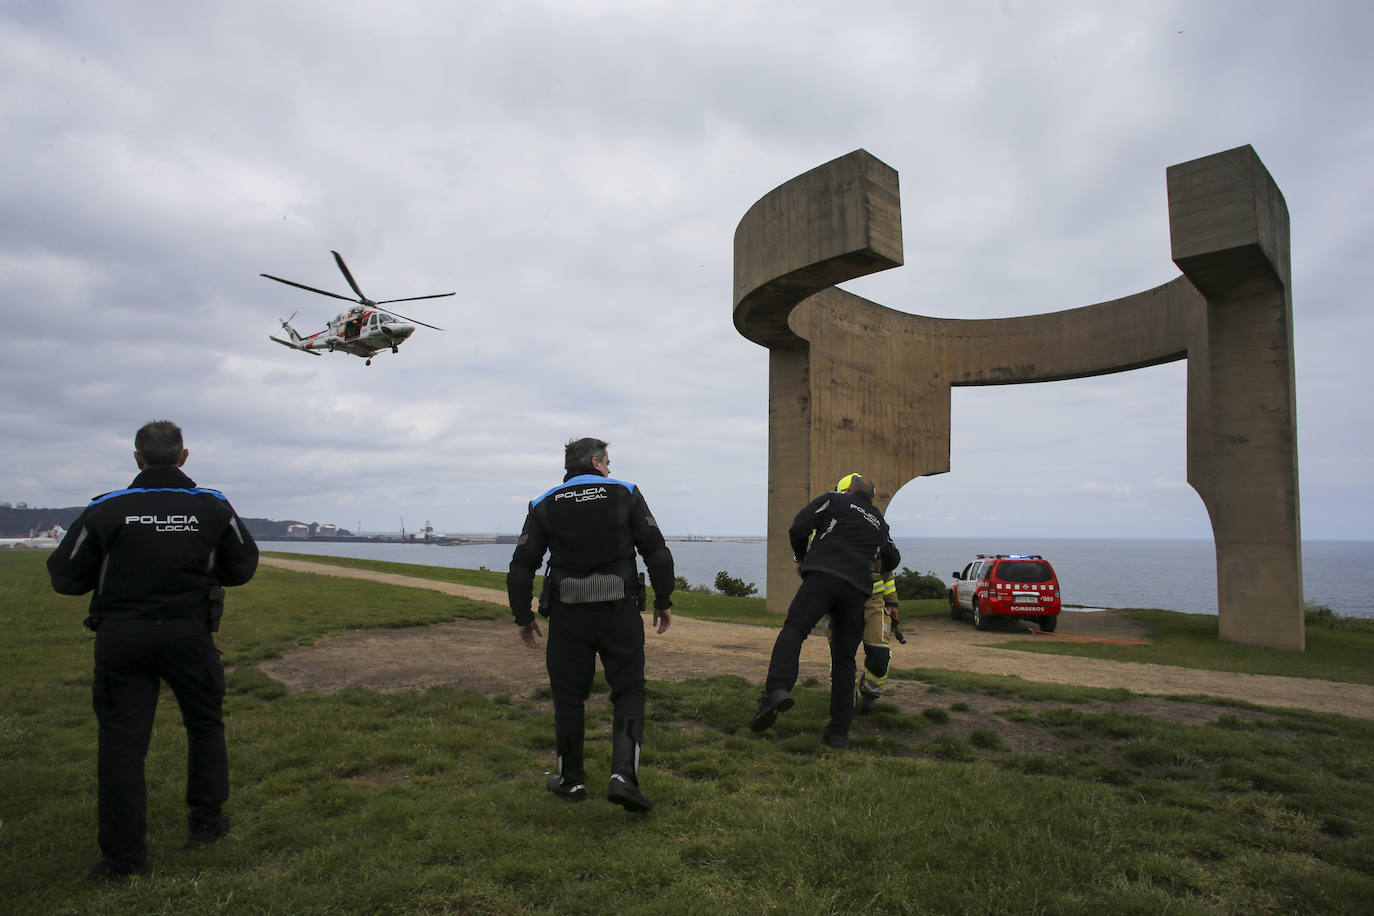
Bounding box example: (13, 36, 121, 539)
(0, 0, 1374, 540)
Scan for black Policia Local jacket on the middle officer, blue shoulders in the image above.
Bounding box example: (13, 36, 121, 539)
(506, 472, 673, 626)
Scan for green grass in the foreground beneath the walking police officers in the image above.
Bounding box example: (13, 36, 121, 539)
(0, 552, 1374, 915)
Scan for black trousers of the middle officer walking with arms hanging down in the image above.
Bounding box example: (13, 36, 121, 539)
(544, 599, 644, 737)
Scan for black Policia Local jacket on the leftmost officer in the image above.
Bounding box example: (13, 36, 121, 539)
(48, 467, 258, 619)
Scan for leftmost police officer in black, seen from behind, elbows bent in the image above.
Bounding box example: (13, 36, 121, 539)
(48, 420, 258, 879)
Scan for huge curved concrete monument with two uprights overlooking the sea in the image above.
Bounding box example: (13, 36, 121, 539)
(734, 147, 1305, 650)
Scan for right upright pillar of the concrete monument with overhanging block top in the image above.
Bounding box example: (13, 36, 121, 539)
(1168, 147, 1307, 651)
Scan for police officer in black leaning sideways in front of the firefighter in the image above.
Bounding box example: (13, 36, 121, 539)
(749, 475, 901, 747)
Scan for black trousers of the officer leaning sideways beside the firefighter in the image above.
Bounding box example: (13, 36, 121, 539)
(764, 573, 868, 735)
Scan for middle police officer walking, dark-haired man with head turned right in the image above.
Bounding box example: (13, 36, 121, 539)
(506, 438, 673, 812)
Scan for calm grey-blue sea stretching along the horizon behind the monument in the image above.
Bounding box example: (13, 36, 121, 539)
(261, 537, 1374, 618)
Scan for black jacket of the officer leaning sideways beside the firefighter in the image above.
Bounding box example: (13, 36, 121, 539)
(787, 493, 901, 595)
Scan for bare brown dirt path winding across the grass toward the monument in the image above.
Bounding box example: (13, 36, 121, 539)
(258, 556, 1374, 720)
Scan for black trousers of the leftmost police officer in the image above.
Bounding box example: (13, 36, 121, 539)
(92, 618, 229, 867)
